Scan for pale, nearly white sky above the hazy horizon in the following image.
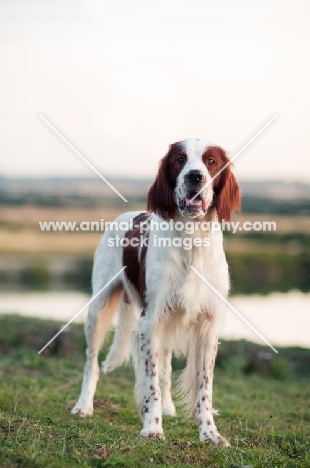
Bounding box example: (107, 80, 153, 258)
(0, 0, 310, 182)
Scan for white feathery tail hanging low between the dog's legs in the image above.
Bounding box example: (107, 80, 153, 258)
(102, 291, 140, 374)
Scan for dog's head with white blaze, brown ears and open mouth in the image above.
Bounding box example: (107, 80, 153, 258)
(148, 139, 241, 222)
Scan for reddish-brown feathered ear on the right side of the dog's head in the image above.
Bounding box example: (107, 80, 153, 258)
(214, 148, 241, 222)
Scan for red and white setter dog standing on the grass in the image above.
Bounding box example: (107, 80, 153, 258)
(72, 139, 240, 446)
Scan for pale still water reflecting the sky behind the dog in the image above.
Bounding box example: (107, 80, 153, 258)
(0, 291, 310, 348)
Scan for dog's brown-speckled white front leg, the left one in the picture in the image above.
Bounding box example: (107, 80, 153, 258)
(136, 316, 164, 439)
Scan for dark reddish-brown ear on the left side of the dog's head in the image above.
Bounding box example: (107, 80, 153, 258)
(147, 145, 176, 220)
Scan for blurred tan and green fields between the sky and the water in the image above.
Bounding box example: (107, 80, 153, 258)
(0, 179, 310, 295)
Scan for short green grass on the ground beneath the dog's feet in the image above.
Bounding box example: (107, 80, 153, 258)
(0, 316, 310, 468)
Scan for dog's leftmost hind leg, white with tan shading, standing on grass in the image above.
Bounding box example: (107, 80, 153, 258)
(71, 288, 122, 416)
